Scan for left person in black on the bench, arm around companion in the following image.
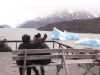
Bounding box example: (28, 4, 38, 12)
(17, 34, 47, 75)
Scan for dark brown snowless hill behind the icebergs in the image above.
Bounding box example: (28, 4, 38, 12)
(38, 18, 100, 33)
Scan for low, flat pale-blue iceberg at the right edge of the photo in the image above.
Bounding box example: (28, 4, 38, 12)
(75, 38, 100, 46)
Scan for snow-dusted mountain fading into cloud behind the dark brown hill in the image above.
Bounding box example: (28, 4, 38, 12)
(18, 11, 95, 28)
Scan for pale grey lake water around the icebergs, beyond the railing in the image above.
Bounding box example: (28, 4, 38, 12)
(0, 28, 100, 49)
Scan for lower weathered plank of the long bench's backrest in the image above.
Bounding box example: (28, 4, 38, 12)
(13, 54, 100, 60)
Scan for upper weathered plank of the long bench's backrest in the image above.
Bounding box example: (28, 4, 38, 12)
(13, 49, 100, 54)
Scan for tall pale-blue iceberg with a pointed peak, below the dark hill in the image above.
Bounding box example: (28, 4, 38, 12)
(51, 27, 80, 40)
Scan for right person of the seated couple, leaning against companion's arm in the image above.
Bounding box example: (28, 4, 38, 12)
(33, 33, 51, 75)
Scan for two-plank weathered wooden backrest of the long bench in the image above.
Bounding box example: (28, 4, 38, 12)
(13, 49, 100, 60)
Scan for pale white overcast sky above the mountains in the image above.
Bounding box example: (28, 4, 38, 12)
(0, 0, 100, 27)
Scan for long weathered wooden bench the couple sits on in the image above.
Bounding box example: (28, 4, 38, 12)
(13, 49, 100, 75)
